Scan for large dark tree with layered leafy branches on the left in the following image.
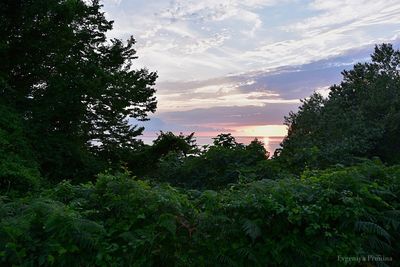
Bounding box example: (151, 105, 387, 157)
(0, 0, 157, 179)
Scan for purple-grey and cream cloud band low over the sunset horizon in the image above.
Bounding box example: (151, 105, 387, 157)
(144, 46, 390, 134)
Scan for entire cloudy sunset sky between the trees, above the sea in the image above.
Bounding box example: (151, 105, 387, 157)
(102, 0, 400, 150)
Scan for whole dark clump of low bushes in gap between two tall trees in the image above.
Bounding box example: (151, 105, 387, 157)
(139, 133, 284, 189)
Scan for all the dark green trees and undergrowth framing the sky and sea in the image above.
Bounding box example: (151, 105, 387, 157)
(0, 0, 400, 266)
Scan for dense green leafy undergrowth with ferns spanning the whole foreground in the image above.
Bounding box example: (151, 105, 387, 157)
(0, 161, 400, 266)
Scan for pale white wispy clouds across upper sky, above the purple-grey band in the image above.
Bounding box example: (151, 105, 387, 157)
(104, 0, 400, 81)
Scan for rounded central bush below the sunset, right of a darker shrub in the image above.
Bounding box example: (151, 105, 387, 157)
(148, 134, 272, 190)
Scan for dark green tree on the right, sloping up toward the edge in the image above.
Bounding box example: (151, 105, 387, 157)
(280, 44, 400, 173)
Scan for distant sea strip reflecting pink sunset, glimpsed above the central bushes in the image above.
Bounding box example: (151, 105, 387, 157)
(140, 136, 283, 155)
